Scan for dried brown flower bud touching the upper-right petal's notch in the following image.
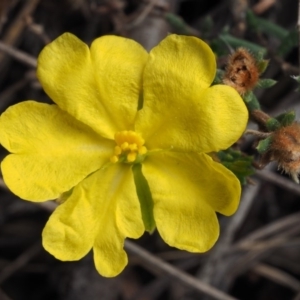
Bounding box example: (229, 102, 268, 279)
(223, 48, 260, 95)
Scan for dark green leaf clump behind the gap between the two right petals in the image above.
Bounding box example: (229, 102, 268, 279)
(217, 148, 254, 184)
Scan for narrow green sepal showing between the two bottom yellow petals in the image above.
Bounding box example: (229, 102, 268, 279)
(132, 164, 156, 233)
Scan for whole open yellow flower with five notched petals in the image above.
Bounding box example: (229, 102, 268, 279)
(0, 34, 248, 276)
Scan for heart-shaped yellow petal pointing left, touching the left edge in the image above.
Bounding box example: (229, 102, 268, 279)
(0, 101, 114, 201)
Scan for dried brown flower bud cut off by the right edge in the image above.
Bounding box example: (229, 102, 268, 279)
(262, 122, 300, 183)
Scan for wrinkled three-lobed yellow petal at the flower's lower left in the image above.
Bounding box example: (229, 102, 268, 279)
(43, 164, 144, 277)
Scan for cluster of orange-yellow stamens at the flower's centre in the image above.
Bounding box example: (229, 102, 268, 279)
(110, 130, 147, 163)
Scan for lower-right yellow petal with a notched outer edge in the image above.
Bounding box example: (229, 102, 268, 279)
(143, 152, 241, 252)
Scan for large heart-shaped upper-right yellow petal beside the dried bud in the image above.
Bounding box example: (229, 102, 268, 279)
(135, 35, 248, 152)
